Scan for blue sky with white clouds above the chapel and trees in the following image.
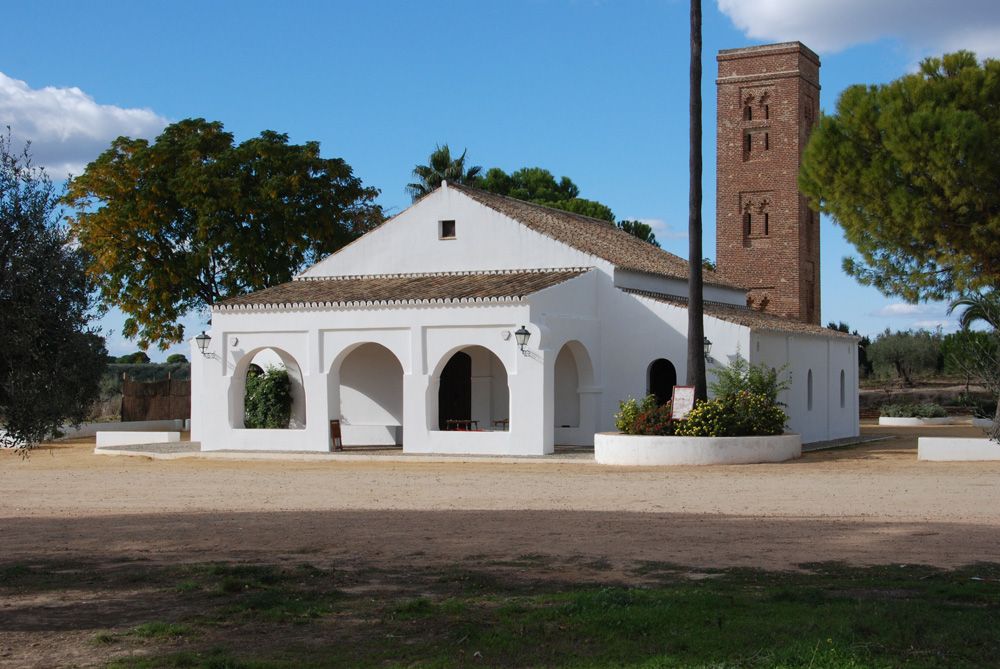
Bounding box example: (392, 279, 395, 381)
(0, 0, 1000, 360)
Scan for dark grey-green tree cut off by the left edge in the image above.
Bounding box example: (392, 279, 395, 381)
(0, 133, 107, 449)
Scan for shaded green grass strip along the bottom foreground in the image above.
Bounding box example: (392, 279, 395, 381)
(0, 556, 1000, 669)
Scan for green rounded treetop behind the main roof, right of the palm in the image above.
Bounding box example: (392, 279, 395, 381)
(474, 167, 615, 223)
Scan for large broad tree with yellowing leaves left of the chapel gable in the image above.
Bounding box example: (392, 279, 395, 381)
(65, 119, 382, 349)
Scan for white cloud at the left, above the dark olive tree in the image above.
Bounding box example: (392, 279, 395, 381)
(0, 72, 168, 180)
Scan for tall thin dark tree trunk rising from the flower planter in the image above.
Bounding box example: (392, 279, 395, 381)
(687, 0, 708, 400)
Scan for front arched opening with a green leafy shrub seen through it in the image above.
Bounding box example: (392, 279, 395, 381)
(230, 347, 306, 430)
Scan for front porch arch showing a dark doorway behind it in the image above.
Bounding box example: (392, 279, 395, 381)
(433, 346, 510, 430)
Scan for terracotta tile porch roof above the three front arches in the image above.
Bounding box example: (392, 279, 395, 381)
(214, 268, 589, 311)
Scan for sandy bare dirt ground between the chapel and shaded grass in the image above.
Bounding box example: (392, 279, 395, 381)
(0, 427, 1000, 666)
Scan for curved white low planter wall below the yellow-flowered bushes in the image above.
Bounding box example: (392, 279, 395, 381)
(594, 432, 802, 466)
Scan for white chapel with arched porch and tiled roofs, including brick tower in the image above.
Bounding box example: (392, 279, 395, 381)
(191, 43, 859, 455)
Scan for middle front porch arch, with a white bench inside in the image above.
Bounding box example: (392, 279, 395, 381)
(330, 342, 403, 446)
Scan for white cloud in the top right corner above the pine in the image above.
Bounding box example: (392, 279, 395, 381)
(717, 0, 1000, 58)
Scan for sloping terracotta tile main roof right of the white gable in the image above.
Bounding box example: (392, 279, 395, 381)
(448, 183, 742, 288)
